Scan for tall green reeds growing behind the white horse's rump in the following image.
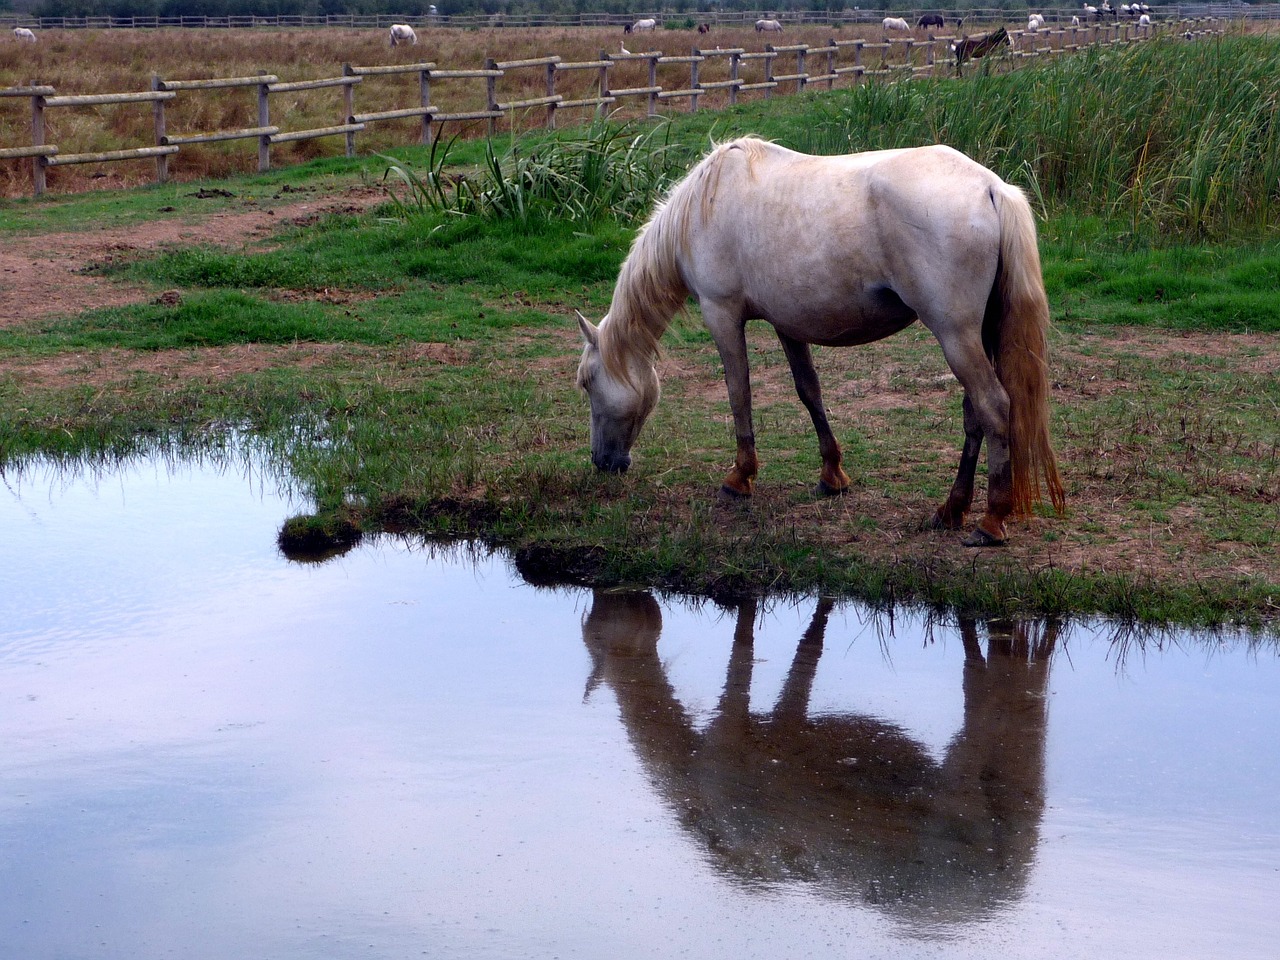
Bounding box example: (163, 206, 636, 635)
(796, 37, 1280, 239)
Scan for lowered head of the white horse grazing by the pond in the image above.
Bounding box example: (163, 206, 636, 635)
(577, 314, 660, 474)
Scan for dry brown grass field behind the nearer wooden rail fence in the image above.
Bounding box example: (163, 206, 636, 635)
(0, 26, 942, 196)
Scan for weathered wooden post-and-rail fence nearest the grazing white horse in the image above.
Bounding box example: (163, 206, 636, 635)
(0, 19, 1222, 196)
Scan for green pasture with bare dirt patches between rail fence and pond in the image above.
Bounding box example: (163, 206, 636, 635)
(0, 40, 1280, 630)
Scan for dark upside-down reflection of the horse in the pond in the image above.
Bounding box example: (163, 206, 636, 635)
(582, 591, 1056, 927)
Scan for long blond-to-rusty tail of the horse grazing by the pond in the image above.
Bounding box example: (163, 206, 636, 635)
(995, 184, 1066, 516)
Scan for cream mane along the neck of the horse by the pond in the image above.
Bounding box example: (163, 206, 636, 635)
(599, 137, 769, 383)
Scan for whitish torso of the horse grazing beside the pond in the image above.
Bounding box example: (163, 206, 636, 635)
(673, 138, 1001, 330)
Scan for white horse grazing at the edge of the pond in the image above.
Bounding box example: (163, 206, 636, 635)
(577, 137, 1065, 547)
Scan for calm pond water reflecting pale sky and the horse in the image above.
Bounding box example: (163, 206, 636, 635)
(0, 466, 1280, 960)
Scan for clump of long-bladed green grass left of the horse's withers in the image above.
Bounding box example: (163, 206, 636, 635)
(383, 123, 682, 225)
